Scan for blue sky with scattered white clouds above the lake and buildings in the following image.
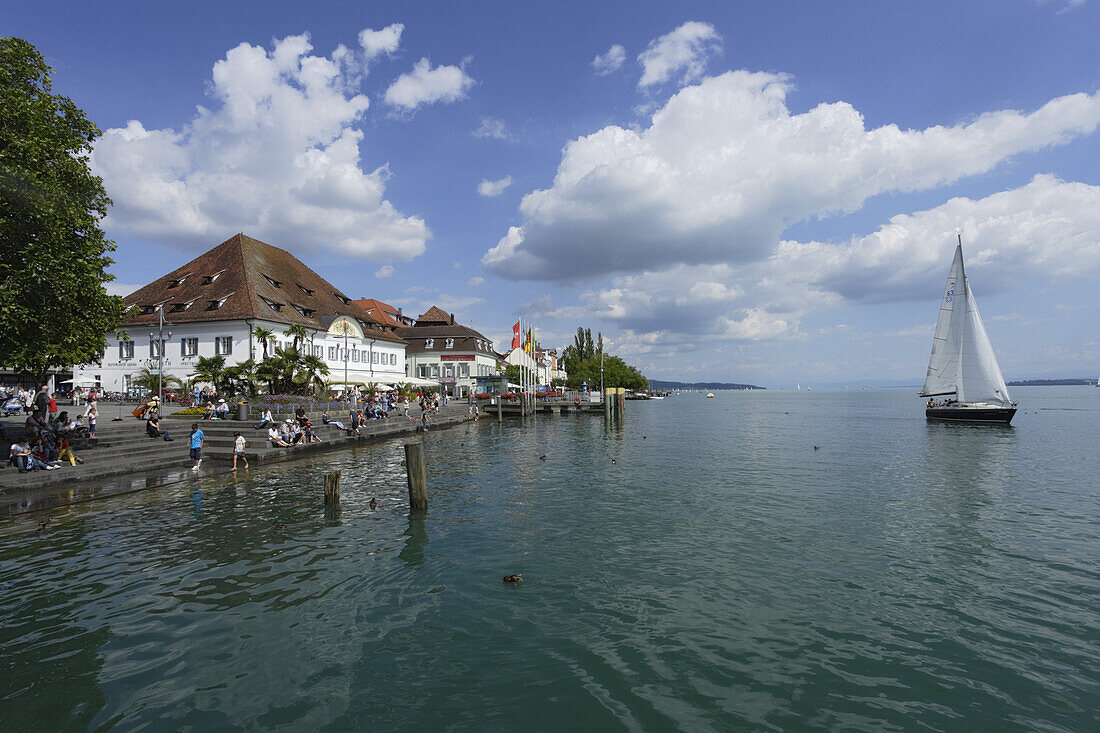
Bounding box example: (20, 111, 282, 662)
(8, 0, 1100, 387)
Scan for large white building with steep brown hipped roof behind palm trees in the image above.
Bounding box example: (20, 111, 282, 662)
(75, 234, 406, 392)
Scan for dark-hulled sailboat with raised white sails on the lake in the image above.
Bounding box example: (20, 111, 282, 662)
(921, 234, 1016, 425)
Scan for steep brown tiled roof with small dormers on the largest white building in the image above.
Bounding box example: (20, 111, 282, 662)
(124, 234, 402, 341)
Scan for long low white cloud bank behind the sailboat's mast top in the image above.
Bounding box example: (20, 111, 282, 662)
(552, 175, 1100, 350)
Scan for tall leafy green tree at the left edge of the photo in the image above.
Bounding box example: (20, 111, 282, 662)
(0, 39, 125, 379)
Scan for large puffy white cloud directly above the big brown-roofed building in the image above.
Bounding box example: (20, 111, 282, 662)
(91, 35, 431, 261)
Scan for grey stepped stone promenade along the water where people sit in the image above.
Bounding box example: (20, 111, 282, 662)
(0, 401, 484, 516)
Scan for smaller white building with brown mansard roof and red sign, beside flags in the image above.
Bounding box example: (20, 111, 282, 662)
(397, 306, 497, 397)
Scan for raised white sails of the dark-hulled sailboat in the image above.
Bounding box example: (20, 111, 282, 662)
(921, 243, 1012, 405)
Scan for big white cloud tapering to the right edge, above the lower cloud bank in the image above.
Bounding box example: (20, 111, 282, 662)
(482, 72, 1100, 280)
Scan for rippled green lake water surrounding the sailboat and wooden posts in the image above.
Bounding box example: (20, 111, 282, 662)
(0, 387, 1100, 731)
